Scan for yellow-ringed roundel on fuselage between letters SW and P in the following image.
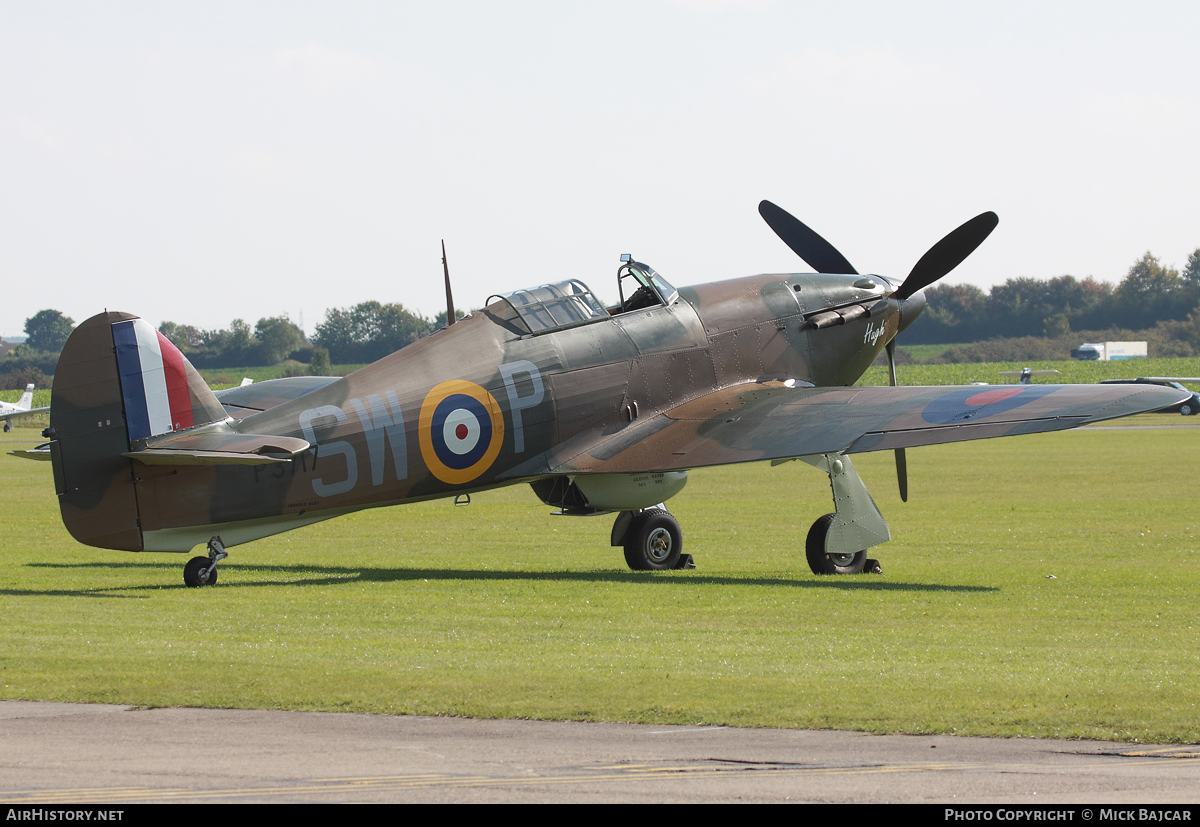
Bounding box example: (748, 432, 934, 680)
(418, 379, 504, 485)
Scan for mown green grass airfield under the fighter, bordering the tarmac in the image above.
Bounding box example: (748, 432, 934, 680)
(0, 414, 1200, 742)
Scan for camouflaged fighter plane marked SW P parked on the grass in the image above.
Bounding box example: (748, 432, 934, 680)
(14, 202, 1183, 586)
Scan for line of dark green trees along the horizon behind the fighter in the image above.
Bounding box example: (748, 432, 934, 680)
(0, 248, 1200, 389)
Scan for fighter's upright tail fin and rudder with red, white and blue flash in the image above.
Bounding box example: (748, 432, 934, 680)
(50, 312, 226, 551)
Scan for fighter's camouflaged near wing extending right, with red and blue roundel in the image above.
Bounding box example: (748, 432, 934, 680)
(548, 383, 1189, 474)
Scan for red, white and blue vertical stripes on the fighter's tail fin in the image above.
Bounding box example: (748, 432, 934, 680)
(113, 319, 194, 442)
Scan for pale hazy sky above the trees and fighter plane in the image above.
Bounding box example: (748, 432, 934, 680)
(0, 0, 1200, 336)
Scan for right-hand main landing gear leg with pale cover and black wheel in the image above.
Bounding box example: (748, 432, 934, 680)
(800, 454, 892, 574)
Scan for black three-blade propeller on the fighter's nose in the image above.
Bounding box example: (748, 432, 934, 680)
(758, 200, 1000, 502)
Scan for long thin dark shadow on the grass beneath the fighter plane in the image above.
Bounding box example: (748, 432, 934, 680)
(14, 563, 1001, 597)
